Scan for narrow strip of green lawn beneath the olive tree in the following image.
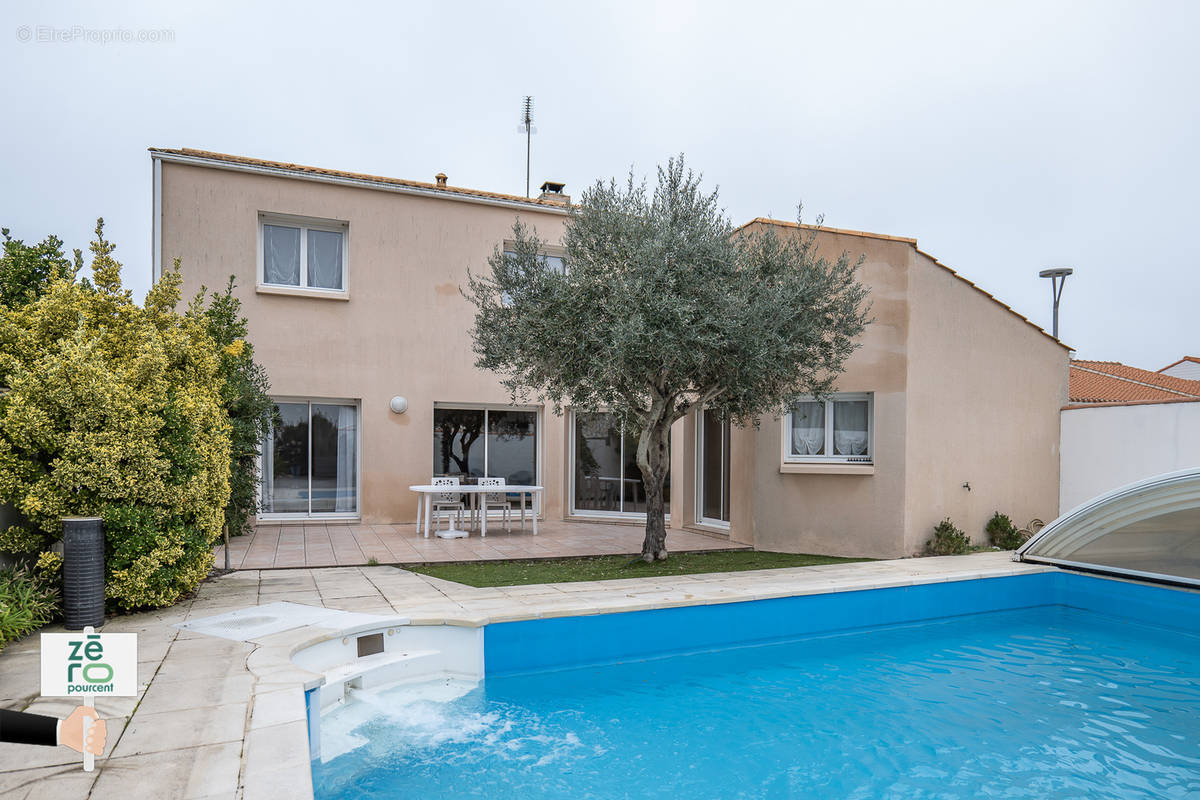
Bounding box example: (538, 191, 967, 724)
(409, 551, 870, 587)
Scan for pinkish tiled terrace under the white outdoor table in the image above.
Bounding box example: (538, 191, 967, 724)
(215, 521, 744, 570)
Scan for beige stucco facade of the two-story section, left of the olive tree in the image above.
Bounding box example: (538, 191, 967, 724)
(162, 163, 585, 523)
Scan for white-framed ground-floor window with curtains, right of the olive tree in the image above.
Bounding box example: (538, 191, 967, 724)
(784, 392, 875, 464)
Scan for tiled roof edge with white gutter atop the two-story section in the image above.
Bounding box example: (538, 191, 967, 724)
(150, 148, 566, 213)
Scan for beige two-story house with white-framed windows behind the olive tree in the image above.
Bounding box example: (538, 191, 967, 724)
(151, 149, 1068, 557)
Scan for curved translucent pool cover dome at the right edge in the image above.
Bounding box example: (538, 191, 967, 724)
(1013, 469, 1200, 587)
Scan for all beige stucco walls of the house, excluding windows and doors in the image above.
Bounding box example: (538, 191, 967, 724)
(161, 163, 1067, 557)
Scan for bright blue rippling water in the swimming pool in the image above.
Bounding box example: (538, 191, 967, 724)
(313, 606, 1200, 800)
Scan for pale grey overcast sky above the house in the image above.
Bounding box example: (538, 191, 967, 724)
(0, 0, 1200, 367)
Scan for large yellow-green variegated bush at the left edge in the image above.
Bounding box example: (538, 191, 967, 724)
(0, 222, 229, 609)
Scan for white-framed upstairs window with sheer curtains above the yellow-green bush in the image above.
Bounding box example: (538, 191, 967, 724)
(258, 213, 349, 295)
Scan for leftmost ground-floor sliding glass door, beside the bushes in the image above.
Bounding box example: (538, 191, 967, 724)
(262, 401, 359, 517)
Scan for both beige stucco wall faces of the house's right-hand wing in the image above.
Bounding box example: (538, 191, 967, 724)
(732, 220, 1067, 558)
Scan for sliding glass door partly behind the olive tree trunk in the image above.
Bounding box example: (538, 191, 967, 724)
(571, 411, 671, 516)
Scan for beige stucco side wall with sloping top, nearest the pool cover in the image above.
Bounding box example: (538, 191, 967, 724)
(904, 249, 1068, 553)
